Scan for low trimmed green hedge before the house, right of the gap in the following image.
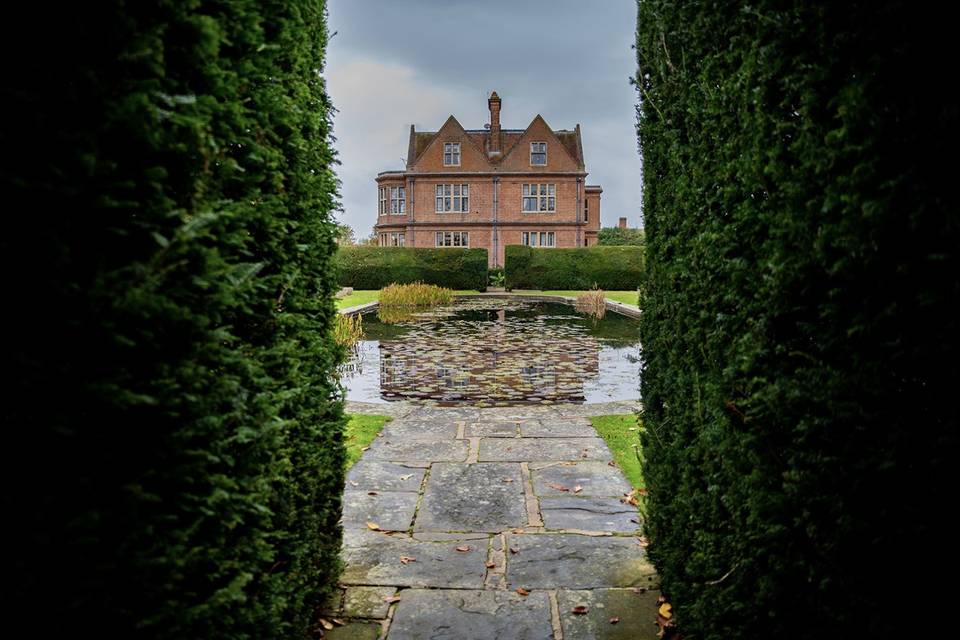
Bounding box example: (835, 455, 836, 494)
(504, 245, 643, 291)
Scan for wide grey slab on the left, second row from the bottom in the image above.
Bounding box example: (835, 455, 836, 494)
(340, 532, 488, 589)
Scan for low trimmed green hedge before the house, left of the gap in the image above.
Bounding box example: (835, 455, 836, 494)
(336, 246, 487, 291)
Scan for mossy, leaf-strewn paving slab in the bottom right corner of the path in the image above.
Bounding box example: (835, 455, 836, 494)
(557, 589, 660, 640)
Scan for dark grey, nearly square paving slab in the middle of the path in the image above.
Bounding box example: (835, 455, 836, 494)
(414, 462, 526, 533)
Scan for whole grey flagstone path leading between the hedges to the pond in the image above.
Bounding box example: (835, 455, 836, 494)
(326, 403, 658, 640)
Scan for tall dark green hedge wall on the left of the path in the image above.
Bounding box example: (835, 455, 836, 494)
(0, 0, 344, 639)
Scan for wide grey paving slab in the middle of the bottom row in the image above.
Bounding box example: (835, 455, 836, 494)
(388, 589, 553, 640)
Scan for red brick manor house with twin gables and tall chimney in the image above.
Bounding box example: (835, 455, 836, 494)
(374, 91, 603, 267)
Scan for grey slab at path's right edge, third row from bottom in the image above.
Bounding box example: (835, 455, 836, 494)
(540, 494, 640, 533)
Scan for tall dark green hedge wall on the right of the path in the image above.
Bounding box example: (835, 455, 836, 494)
(636, 0, 960, 639)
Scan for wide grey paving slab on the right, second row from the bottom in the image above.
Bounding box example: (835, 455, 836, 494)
(507, 533, 656, 589)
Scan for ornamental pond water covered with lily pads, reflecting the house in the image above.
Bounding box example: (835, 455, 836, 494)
(341, 298, 640, 406)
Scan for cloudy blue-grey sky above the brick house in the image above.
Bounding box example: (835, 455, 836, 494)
(325, 0, 640, 239)
